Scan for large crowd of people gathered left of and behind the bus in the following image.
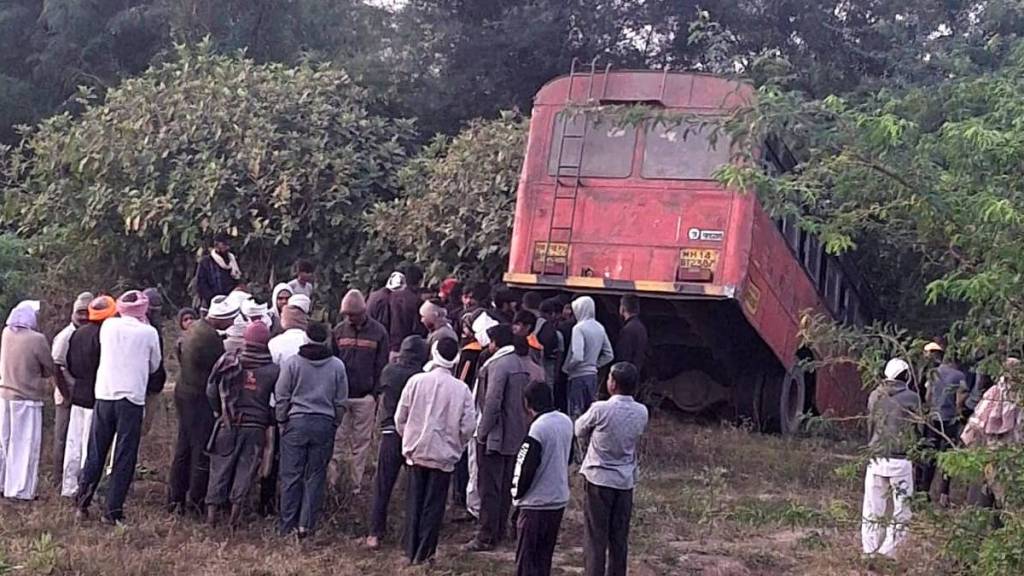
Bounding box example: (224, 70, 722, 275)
(0, 236, 648, 576)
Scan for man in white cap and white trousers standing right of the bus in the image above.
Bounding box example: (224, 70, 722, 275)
(861, 358, 922, 557)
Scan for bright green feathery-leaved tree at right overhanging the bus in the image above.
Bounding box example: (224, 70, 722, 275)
(704, 32, 1024, 575)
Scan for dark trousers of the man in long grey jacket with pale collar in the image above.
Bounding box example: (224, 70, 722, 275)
(476, 444, 515, 546)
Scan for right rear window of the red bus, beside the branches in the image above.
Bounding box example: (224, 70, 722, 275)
(641, 124, 730, 180)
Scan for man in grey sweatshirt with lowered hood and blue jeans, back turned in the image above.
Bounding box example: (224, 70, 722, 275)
(274, 324, 348, 539)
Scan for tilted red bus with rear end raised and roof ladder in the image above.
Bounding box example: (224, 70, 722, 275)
(505, 65, 871, 433)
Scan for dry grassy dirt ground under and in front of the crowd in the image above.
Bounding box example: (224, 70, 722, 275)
(0, 393, 937, 576)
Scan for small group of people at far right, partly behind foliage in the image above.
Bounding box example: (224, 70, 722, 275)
(861, 341, 1024, 557)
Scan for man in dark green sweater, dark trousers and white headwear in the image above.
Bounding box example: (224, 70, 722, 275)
(167, 296, 239, 515)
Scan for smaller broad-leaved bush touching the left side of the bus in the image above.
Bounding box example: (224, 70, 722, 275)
(368, 113, 527, 280)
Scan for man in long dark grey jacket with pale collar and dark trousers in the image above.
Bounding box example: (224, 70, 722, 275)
(466, 324, 530, 551)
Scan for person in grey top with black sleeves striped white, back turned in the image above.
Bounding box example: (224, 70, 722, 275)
(512, 382, 572, 576)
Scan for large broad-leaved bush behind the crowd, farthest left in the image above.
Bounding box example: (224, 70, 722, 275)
(0, 44, 413, 305)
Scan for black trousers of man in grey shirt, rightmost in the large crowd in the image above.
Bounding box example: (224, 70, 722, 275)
(583, 482, 633, 576)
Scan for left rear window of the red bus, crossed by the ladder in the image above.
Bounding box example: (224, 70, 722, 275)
(548, 114, 637, 178)
